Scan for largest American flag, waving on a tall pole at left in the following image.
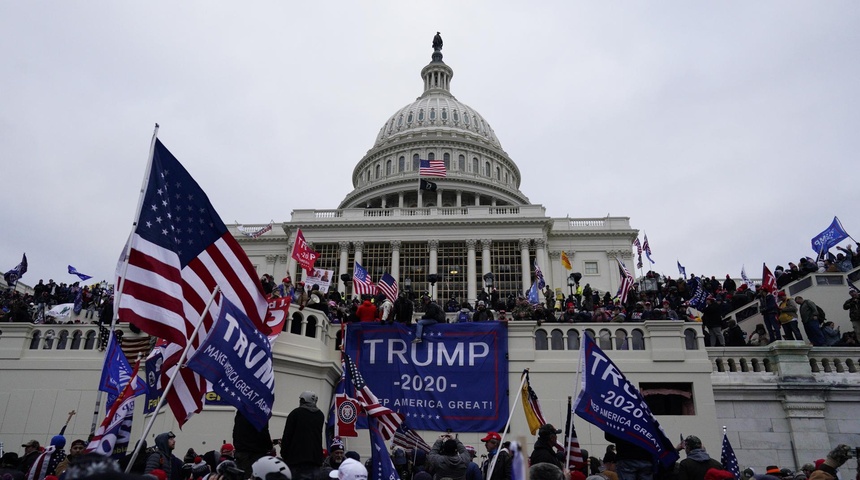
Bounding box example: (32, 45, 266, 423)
(118, 139, 269, 426)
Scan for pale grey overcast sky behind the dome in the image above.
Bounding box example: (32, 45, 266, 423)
(0, 1, 860, 285)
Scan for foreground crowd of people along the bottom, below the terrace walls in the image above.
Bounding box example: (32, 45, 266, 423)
(5, 391, 860, 480)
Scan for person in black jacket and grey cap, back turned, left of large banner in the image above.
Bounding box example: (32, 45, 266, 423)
(281, 392, 325, 480)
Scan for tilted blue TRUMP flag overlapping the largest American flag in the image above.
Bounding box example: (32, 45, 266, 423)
(188, 297, 275, 430)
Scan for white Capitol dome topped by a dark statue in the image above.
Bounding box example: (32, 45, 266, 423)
(338, 39, 529, 208)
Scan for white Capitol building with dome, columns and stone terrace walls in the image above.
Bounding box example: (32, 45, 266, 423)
(0, 36, 860, 478)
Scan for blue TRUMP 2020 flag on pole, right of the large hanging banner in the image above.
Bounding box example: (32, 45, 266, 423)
(574, 335, 679, 467)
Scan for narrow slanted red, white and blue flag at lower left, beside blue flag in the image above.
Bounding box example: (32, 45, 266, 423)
(85, 361, 140, 459)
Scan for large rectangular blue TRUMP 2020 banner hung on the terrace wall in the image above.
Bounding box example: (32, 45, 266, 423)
(344, 322, 508, 432)
